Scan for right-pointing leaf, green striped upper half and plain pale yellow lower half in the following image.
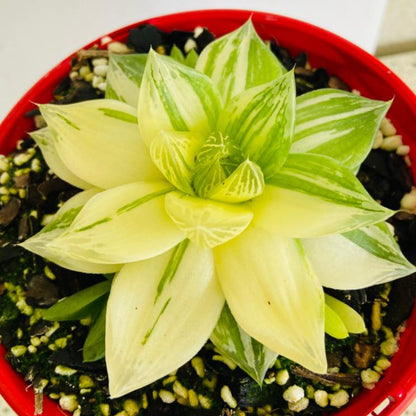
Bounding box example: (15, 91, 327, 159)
(252, 154, 394, 238)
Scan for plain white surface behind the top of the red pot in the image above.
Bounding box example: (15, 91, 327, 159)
(0, 0, 386, 121)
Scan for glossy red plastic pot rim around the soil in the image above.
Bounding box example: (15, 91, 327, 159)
(0, 10, 416, 416)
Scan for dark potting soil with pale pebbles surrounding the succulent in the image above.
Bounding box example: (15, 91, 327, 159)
(0, 25, 416, 416)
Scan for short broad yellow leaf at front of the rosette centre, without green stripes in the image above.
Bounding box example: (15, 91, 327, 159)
(165, 192, 253, 247)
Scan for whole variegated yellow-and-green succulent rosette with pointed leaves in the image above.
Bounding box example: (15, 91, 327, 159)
(22, 21, 415, 397)
